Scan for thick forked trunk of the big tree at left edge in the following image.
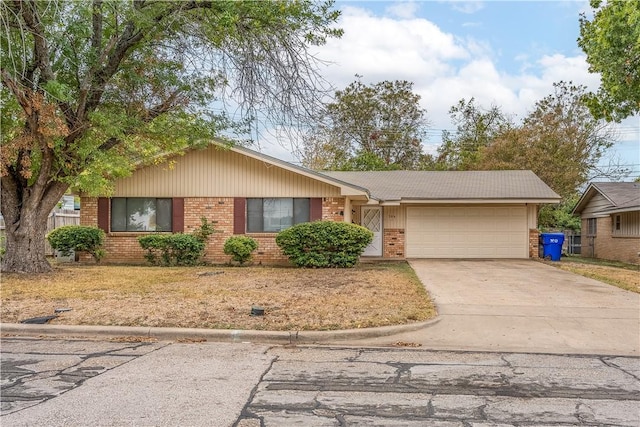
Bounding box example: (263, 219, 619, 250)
(1, 177, 68, 273)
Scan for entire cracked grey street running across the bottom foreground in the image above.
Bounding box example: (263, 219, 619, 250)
(0, 337, 640, 427)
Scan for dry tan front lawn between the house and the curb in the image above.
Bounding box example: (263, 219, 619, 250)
(0, 262, 436, 330)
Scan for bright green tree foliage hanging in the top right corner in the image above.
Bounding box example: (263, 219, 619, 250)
(578, 0, 640, 121)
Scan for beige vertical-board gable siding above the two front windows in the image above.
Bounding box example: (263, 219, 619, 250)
(114, 147, 340, 197)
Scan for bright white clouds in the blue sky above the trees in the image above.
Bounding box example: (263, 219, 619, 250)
(262, 2, 637, 174)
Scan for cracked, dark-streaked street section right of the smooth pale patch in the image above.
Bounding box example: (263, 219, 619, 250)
(236, 348, 640, 427)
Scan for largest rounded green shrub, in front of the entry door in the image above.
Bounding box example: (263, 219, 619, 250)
(276, 221, 373, 267)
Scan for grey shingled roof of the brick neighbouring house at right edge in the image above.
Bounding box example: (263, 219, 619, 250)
(573, 182, 640, 214)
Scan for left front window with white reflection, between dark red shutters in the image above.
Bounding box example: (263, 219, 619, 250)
(111, 197, 172, 231)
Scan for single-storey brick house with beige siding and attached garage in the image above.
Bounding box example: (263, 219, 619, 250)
(81, 145, 560, 263)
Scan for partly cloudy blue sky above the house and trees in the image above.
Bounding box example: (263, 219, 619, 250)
(261, 0, 640, 179)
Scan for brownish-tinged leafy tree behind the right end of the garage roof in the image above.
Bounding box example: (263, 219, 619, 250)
(480, 82, 614, 198)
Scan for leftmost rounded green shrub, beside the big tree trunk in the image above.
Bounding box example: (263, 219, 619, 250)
(47, 225, 105, 262)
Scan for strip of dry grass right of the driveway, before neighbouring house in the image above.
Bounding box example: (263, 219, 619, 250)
(546, 256, 640, 293)
